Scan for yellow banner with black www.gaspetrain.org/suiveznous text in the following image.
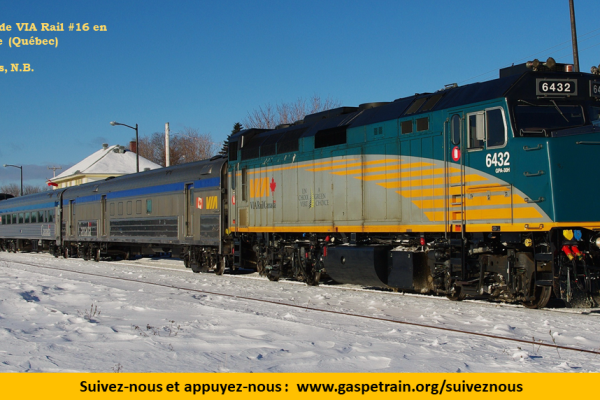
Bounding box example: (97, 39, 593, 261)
(0, 373, 600, 400)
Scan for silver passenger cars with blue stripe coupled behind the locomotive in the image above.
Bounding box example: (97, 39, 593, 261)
(0, 157, 231, 273)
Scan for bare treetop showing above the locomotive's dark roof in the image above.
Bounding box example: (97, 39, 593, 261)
(242, 94, 341, 129)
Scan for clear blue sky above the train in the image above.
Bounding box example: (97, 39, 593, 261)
(0, 0, 600, 185)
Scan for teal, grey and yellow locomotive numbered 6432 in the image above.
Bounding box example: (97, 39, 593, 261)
(228, 59, 600, 307)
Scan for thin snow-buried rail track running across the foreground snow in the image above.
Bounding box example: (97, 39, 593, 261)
(0, 253, 600, 355)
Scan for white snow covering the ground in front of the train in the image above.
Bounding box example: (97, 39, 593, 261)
(0, 253, 600, 372)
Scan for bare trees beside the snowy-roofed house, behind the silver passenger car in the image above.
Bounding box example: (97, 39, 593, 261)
(139, 127, 219, 166)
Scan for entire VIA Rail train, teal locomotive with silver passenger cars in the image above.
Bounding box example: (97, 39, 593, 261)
(0, 58, 600, 308)
